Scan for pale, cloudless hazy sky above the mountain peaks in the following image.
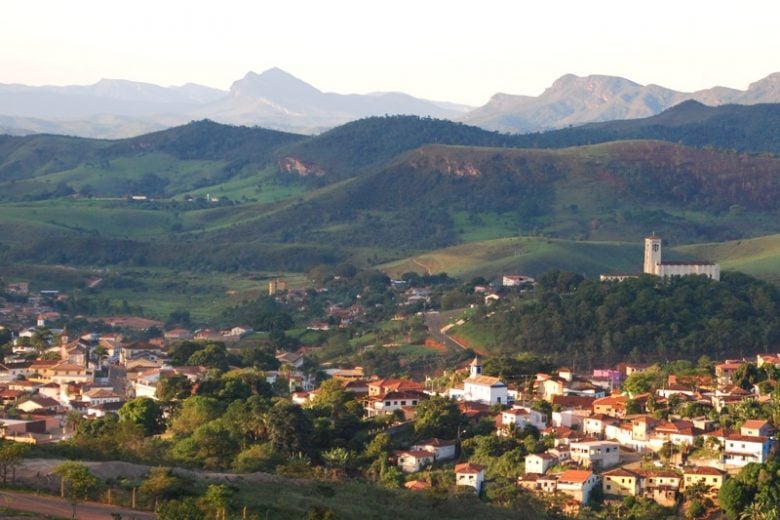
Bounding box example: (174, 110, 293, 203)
(0, 0, 780, 105)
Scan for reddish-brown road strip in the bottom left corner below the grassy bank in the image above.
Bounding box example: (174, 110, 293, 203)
(0, 491, 157, 520)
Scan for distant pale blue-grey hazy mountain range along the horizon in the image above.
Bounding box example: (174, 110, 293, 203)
(0, 68, 780, 138)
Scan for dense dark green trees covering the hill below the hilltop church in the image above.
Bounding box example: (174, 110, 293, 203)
(470, 272, 780, 369)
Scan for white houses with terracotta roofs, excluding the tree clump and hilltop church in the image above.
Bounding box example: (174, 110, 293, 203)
(0, 276, 780, 514)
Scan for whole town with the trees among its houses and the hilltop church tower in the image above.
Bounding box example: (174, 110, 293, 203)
(0, 243, 780, 518)
